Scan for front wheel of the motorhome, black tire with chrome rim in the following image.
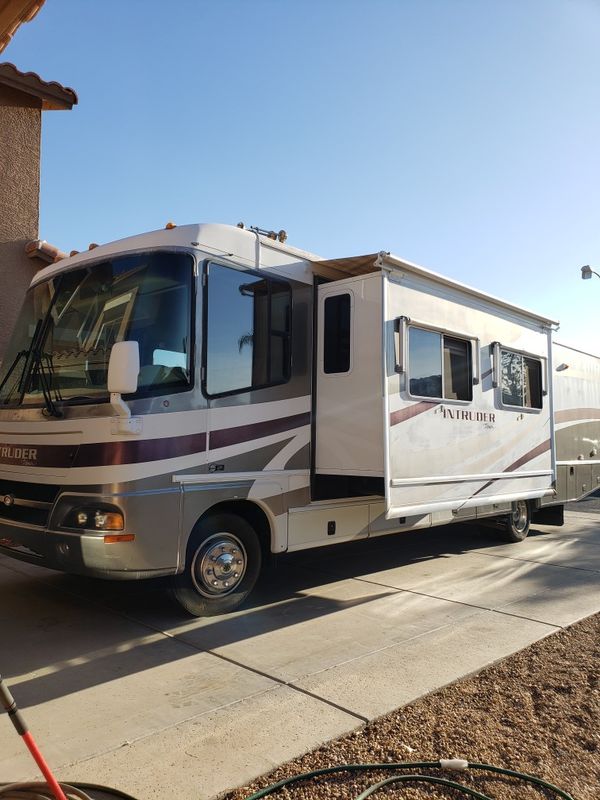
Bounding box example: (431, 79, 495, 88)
(172, 514, 262, 617)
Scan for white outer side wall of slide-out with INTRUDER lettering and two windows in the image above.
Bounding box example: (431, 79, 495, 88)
(384, 270, 553, 518)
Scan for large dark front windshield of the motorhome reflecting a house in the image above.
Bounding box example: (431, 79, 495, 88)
(0, 251, 193, 407)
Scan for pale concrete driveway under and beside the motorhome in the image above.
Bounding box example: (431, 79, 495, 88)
(0, 506, 600, 800)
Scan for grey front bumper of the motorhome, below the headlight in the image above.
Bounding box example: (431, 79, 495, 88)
(0, 520, 175, 580)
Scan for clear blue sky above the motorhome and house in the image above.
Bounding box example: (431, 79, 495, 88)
(0, 0, 600, 354)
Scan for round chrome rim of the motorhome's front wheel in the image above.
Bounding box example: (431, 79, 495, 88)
(191, 533, 248, 597)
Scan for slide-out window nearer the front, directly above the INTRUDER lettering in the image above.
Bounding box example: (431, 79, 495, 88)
(408, 327, 473, 401)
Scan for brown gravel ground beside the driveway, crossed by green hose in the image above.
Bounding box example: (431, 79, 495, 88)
(226, 614, 600, 800)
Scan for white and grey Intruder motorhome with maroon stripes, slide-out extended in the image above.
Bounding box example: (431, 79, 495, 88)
(0, 224, 600, 615)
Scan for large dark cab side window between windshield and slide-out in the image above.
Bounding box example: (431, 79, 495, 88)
(205, 264, 292, 396)
